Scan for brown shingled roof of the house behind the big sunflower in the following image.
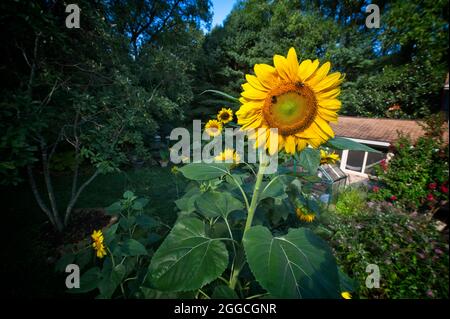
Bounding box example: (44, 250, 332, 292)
(331, 116, 448, 143)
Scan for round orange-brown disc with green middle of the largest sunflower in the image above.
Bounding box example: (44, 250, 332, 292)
(263, 83, 317, 135)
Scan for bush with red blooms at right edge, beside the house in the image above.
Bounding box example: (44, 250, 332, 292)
(369, 116, 449, 211)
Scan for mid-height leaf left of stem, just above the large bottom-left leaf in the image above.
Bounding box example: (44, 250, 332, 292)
(195, 192, 244, 218)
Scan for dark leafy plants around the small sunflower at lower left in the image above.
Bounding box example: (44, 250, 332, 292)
(56, 191, 162, 298)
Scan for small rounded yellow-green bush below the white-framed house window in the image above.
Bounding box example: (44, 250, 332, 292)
(336, 187, 367, 217)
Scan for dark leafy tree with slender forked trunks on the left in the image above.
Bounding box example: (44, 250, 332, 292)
(0, 1, 212, 231)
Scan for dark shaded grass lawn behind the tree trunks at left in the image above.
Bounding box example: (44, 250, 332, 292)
(0, 167, 183, 298)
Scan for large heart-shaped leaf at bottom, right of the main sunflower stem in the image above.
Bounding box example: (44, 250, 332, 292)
(244, 226, 340, 298)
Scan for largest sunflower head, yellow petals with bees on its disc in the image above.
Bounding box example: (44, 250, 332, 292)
(236, 48, 343, 154)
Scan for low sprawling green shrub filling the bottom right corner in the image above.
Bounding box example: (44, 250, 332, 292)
(326, 203, 449, 299)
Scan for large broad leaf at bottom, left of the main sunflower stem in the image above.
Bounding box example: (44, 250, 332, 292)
(148, 217, 228, 291)
